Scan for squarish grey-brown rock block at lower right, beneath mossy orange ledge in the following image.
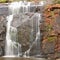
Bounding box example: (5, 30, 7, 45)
(43, 42, 55, 54)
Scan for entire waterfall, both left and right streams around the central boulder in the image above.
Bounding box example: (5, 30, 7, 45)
(5, 1, 43, 57)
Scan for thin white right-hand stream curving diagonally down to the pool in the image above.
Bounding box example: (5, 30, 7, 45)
(23, 13, 41, 58)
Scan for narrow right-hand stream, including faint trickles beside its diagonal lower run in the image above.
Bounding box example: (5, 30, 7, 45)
(23, 13, 41, 57)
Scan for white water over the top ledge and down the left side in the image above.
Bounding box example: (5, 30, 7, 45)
(4, 1, 29, 57)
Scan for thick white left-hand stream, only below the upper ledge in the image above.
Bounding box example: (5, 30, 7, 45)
(5, 15, 21, 57)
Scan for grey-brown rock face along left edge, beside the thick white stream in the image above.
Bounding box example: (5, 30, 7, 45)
(0, 4, 7, 56)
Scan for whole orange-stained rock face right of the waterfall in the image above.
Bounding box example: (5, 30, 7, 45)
(40, 4, 60, 58)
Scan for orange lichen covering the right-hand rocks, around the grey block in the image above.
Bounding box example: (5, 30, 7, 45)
(42, 4, 60, 57)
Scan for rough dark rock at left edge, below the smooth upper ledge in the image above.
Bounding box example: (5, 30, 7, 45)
(0, 16, 6, 56)
